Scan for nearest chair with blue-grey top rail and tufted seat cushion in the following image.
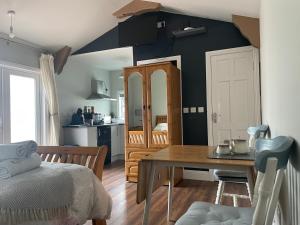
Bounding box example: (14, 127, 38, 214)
(175, 136, 294, 225)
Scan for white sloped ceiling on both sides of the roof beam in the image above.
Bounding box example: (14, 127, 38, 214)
(0, 0, 260, 51)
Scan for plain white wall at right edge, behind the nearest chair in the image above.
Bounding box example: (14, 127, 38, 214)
(261, 0, 300, 225)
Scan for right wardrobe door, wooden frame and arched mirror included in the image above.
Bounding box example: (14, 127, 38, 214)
(147, 65, 169, 148)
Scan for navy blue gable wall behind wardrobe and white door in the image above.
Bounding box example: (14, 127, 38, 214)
(74, 12, 249, 145)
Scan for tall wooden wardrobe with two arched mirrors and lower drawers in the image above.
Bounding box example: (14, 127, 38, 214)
(124, 62, 182, 182)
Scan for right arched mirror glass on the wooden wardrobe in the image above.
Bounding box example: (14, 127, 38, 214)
(150, 70, 168, 145)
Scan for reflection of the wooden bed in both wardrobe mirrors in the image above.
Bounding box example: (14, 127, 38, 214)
(129, 115, 169, 145)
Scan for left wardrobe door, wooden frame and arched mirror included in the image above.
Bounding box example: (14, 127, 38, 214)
(124, 67, 147, 148)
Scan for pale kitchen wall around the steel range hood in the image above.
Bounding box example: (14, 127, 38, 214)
(56, 57, 111, 125)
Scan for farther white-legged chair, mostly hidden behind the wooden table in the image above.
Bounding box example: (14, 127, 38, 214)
(214, 125, 269, 207)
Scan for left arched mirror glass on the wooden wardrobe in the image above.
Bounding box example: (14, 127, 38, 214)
(127, 72, 144, 144)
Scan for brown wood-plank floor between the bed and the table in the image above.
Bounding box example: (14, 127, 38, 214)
(86, 162, 250, 225)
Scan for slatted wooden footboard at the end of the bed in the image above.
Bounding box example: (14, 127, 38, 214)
(37, 146, 107, 225)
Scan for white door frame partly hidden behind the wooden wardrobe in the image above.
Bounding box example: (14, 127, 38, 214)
(137, 55, 183, 143)
